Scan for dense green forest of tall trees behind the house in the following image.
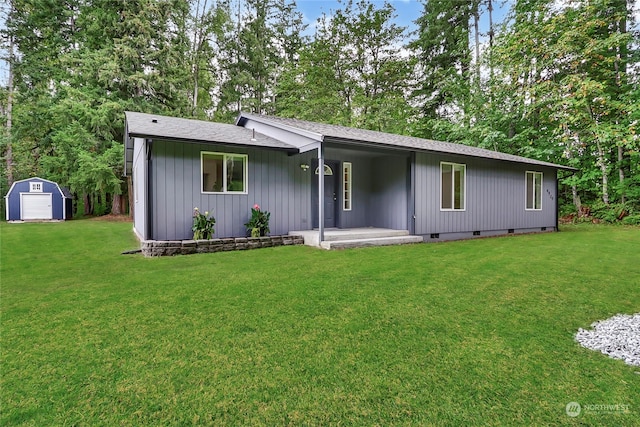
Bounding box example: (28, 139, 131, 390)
(0, 0, 640, 224)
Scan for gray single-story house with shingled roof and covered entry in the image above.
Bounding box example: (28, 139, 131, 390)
(124, 112, 573, 249)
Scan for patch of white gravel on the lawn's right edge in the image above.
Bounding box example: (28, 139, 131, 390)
(576, 313, 640, 366)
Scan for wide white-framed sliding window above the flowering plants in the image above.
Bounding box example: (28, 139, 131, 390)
(201, 152, 247, 194)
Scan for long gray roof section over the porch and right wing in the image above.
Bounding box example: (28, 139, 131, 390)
(236, 113, 577, 170)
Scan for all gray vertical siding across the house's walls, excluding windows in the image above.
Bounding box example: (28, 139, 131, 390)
(138, 139, 557, 240)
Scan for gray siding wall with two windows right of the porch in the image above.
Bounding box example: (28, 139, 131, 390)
(415, 153, 557, 237)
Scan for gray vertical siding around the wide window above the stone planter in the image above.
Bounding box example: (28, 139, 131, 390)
(150, 140, 313, 240)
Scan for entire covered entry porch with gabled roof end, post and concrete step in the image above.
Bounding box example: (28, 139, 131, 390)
(237, 113, 423, 249)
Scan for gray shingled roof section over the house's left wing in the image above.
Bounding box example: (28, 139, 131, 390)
(124, 111, 295, 150)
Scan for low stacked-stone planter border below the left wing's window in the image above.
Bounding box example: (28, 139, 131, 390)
(141, 236, 304, 256)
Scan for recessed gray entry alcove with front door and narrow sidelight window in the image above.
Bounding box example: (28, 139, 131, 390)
(310, 143, 413, 240)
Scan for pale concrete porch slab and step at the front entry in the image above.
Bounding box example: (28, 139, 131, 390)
(289, 227, 423, 250)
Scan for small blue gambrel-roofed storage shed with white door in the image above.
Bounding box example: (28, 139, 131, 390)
(4, 177, 72, 221)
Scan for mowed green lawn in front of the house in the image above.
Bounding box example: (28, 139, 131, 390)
(0, 220, 640, 426)
